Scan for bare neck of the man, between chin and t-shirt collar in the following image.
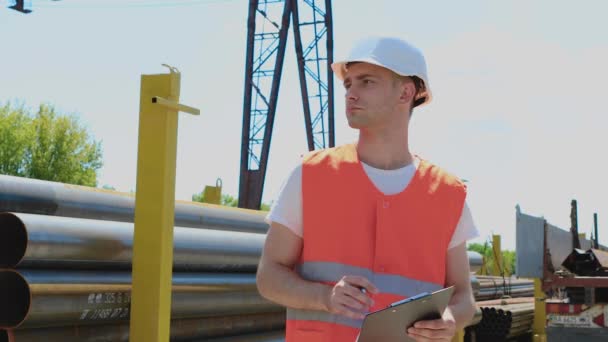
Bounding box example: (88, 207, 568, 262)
(357, 130, 414, 170)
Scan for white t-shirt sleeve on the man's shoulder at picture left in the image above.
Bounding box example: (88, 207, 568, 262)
(265, 164, 302, 237)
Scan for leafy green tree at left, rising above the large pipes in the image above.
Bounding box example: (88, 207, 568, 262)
(0, 103, 102, 186)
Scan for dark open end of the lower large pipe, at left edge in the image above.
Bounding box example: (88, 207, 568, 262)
(0, 270, 31, 328)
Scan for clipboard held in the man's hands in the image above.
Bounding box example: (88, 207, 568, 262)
(357, 286, 454, 342)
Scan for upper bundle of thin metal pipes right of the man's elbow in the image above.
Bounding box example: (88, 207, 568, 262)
(475, 275, 534, 301)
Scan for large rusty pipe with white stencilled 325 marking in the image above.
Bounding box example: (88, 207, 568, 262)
(0, 270, 283, 329)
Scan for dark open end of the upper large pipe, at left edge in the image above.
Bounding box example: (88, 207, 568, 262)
(0, 213, 28, 268)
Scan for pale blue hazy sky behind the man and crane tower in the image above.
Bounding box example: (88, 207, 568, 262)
(0, 0, 608, 248)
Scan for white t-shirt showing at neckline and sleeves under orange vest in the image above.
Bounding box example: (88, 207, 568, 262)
(266, 158, 479, 249)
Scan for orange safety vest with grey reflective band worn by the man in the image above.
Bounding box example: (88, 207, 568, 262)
(286, 144, 466, 342)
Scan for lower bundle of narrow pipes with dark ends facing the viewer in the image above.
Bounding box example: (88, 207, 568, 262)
(474, 298, 534, 342)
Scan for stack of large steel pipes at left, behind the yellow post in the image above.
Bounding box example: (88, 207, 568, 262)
(0, 176, 285, 342)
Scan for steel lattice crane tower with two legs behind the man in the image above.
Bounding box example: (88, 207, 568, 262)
(239, 0, 335, 209)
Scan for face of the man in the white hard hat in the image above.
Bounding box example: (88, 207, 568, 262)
(344, 63, 403, 129)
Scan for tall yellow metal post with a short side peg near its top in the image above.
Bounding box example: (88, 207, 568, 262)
(129, 65, 199, 342)
